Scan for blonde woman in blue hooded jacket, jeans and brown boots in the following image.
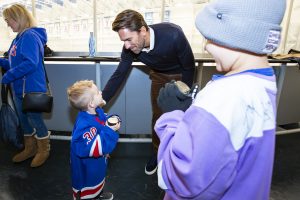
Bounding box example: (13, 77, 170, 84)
(0, 4, 50, 167)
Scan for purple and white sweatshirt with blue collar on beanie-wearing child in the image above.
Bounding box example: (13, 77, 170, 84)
(155, 68, 277, 200)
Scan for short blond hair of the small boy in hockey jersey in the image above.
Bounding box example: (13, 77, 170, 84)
(67, 80, 94, 110)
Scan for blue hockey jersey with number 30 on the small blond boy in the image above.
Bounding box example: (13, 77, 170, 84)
(71, 108, 119, 199)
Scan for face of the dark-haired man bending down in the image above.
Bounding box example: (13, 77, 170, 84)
(118, 27, 147, 54)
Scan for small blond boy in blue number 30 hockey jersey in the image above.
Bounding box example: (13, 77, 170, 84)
(67, 80, 120, 200)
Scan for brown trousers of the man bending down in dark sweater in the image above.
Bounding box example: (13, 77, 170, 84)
(149, 71, 182, 153)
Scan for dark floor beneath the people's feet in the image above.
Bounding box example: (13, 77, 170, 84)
(0, 133, 300, 200)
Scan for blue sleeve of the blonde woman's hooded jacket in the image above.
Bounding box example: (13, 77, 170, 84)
(2, 32, 41, 84)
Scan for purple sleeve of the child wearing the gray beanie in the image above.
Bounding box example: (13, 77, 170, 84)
(155, 106, 237, 199)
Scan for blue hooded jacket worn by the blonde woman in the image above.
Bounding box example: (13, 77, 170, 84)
(0, 27, 47, 97)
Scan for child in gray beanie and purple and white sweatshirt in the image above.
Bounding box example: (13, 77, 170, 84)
(155, 0, 286, 200)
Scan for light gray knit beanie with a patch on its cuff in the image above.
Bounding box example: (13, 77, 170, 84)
(196, 0, 286, 54)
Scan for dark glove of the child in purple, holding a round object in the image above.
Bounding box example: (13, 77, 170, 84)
(157, 80, 199, 113)
